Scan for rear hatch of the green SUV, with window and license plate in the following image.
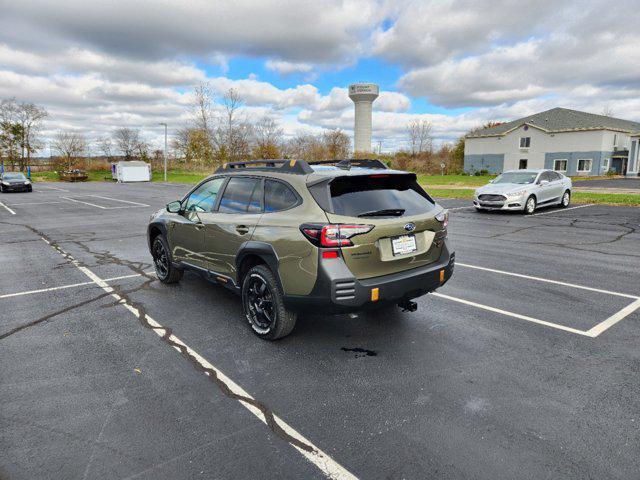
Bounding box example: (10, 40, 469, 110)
(312, 173, 444, 279)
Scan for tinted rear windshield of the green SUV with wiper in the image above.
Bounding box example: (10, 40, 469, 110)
(330, 174, 434, 217)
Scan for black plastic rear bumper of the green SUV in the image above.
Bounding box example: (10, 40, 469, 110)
(284, 240, 455, 313)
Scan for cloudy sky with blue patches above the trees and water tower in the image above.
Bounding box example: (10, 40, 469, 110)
(0, 0, 640, 150)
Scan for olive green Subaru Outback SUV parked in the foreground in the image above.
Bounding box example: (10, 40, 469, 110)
(148, 160, 454, 340)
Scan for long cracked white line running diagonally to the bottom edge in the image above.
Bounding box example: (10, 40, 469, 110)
(40, 237, 357, 480)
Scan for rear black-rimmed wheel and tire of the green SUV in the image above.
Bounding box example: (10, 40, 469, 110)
(242, 265, 297, 340)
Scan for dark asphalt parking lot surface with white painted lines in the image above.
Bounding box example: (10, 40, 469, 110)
(0, 183, 640, 480)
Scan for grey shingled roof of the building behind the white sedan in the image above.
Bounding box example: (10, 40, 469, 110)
(467, 108, 640, 138)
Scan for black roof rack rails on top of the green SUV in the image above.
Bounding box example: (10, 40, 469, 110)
(215, 158, 387, 175)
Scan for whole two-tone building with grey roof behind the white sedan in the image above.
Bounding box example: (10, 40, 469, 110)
(464, 108, 640, 176)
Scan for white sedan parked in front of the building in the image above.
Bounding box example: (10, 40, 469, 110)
(473, 170, 571, 214)
